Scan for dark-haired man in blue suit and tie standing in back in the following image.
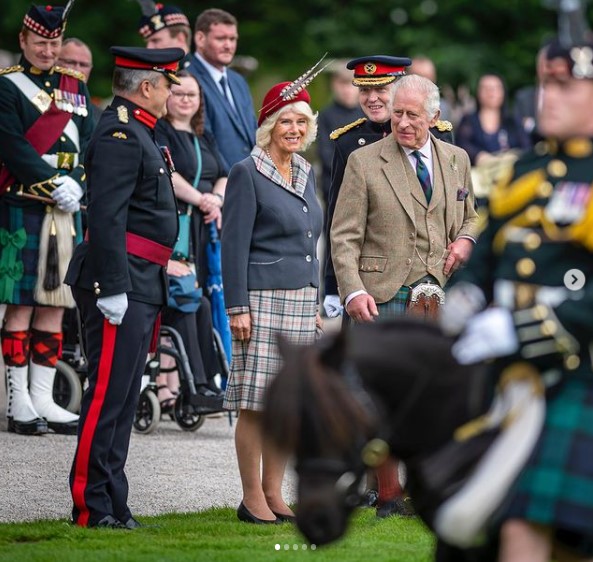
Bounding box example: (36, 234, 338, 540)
(188, 8, 257, 171)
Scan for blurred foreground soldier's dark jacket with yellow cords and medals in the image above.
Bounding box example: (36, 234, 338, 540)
(456, 139, 593, 380)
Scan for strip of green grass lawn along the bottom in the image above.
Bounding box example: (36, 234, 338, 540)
(0, 508, 433, 562)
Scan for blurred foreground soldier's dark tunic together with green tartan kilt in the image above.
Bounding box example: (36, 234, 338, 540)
(456, 139, 593, 538)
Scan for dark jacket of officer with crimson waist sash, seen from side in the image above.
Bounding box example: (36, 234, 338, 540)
(66, 96, 178, 305)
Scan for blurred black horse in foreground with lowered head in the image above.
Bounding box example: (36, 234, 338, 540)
(263, 317, 488, 545)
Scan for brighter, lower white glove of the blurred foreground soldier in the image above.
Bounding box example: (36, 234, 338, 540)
(451, 308, 519, 365)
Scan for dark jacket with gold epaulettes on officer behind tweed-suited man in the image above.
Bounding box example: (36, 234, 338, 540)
(324, 117, 453, 295)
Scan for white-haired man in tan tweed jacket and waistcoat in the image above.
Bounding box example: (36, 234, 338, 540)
(331, 75, 478, 322)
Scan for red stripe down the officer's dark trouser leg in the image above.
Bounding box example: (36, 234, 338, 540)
(72, 319, 117, 527)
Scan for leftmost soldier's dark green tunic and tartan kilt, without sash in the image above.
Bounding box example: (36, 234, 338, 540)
(0, 59, 93, 306)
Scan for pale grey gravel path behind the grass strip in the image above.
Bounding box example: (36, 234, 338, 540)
(0, 384, 294, 522)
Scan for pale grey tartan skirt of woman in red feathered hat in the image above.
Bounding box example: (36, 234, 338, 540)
(224, 286, 318, 411)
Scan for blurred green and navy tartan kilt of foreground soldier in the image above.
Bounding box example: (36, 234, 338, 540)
(504, 376, 593, 541)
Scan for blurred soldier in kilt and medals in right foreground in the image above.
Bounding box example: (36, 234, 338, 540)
(442, 32, 593, 562)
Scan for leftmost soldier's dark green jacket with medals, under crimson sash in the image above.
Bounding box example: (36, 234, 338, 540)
(0, 58, 93, 199)
